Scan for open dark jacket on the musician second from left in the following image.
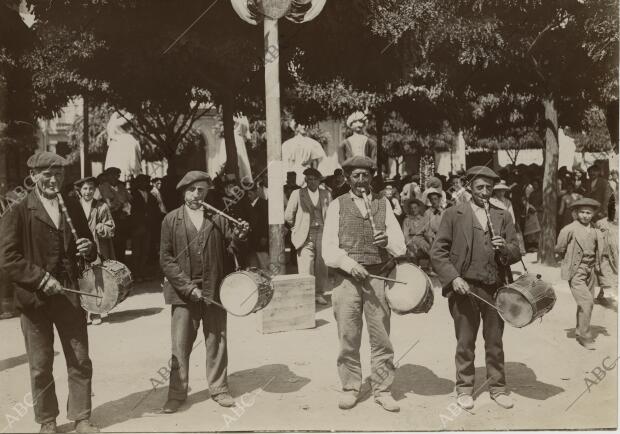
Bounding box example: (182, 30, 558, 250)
(159, 205, 245, 304)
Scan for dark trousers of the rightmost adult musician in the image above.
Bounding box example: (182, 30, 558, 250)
(448, 282, 506, 395)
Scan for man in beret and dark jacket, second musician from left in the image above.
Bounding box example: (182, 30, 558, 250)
(159, 171, 249, 413)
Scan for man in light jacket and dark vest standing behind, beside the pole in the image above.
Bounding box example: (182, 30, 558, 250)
(284, 168, 332, 305)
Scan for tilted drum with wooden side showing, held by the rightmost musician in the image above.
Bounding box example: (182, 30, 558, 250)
(495, 273, 556, 328)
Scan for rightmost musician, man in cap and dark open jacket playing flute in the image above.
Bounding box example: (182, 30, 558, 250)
(430, 166, 521, 409)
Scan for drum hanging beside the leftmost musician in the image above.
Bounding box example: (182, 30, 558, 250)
(78, 259, 133, 314)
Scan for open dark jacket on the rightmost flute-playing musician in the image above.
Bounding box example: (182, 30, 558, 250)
(430, 203, 521, 296)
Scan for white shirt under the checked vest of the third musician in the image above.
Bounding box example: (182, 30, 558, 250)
(323, 192, 407, 273)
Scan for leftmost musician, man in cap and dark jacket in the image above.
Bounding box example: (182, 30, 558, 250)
(0, 152, 98, 432)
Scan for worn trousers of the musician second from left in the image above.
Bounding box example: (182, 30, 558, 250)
(168, 302, 228, 401)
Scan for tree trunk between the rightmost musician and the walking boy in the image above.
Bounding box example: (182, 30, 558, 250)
(539, 96, 560, 266)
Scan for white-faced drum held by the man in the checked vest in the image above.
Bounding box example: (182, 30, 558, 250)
(386, 262, 434, 315)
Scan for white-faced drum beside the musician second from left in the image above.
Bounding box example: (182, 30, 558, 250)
(220, 269, 273, 316)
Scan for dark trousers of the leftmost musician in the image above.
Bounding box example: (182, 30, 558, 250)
(21, 294, 93, 424)
